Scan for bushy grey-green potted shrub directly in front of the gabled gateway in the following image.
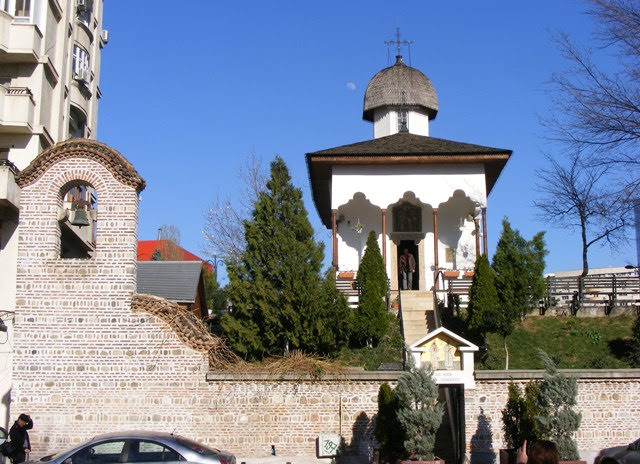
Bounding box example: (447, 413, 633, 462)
(395, 368, 444, 464)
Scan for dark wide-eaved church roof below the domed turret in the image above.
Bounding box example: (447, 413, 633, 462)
(306, 132, 512, 228)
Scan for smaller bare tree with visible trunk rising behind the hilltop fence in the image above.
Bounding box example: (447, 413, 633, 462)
(534, 152, 632, 308)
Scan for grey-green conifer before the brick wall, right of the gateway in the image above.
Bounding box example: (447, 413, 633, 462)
(538, 350, 582, 461)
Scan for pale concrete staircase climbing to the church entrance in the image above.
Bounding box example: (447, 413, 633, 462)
(400, 290, 436, 345)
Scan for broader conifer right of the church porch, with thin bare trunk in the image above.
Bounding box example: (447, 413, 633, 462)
(493, 218, 547, 369)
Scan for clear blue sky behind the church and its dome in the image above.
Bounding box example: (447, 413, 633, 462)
(98, 0, 635, 280)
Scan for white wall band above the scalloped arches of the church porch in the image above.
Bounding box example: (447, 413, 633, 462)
(331, 164, 486, 209)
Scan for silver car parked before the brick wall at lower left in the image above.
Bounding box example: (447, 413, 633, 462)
(40, 432, 236, 464)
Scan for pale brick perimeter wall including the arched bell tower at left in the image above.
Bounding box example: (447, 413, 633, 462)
(11, 142, 640, 462)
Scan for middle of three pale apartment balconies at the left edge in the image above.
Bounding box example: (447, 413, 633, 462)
(0, 85, 36, 134)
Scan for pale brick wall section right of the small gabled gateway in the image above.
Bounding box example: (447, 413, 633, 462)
(465, 369, 640, 463)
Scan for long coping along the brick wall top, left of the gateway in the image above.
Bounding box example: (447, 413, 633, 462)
(206, 370, 404, 382)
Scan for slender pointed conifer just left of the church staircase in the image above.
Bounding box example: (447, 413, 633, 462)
(356, 231, 390, 344)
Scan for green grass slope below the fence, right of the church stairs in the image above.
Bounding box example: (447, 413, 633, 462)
(476, 316, 635, 369)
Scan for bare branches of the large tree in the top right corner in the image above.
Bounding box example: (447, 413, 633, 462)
(545, 0, 640, 198)
